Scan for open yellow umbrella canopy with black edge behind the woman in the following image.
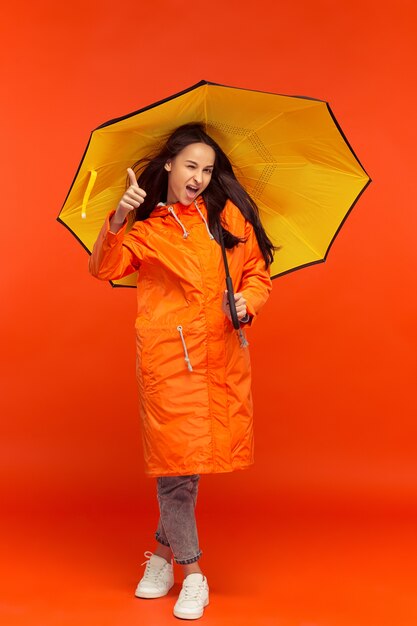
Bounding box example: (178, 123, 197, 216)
(58, 81, 370, 286)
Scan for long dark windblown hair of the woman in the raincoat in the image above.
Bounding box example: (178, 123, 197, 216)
(133, 122, 278, 267)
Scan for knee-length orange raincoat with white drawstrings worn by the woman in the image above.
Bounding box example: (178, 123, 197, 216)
(89, 197, 272, 476)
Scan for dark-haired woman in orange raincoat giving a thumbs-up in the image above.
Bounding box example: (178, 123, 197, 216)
(89, 123, 274, 619)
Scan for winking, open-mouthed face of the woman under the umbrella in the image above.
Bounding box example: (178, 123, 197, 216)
(165, 143, 216, 206)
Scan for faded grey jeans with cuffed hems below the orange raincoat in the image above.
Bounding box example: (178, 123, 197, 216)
(155, 474, 203, 564)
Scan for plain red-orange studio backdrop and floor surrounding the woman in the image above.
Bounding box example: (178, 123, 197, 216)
(0, 0, 417, 626)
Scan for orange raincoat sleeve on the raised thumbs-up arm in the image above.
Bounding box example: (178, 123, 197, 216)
(88, 211, 143, 280)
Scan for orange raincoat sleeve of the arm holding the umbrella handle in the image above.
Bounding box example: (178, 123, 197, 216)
(239, 222, 272, 326)
